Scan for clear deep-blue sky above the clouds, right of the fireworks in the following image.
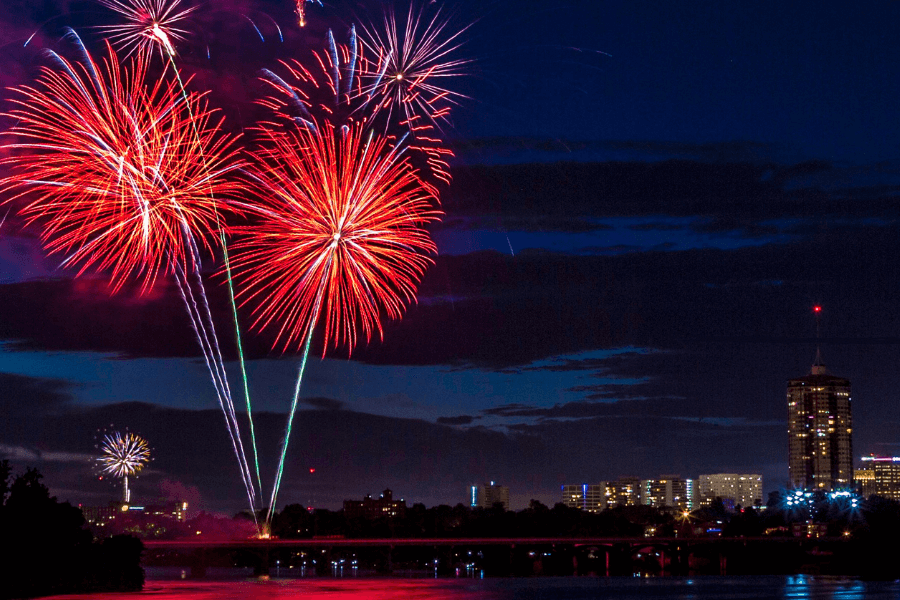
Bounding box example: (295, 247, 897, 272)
(461, 1, 900, 163)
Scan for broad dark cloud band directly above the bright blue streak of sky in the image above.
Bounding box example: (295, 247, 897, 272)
(0, 164, 900, 368)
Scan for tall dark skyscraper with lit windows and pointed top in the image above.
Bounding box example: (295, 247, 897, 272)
(787, 351, 853, 491)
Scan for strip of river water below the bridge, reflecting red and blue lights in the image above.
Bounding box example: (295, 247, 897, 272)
(44, 570, 900, 600)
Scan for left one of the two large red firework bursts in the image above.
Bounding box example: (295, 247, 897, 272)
(0, 37, 241, 291)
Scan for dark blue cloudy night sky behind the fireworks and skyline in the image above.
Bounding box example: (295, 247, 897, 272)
(0, 0, 900, 514)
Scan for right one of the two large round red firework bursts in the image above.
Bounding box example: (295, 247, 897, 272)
(233, 123, 440, 356)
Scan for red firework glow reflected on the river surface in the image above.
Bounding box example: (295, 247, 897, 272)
(45, 579, 495, 600)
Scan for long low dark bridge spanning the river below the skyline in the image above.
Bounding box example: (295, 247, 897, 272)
(144, 537, 852, 575)
